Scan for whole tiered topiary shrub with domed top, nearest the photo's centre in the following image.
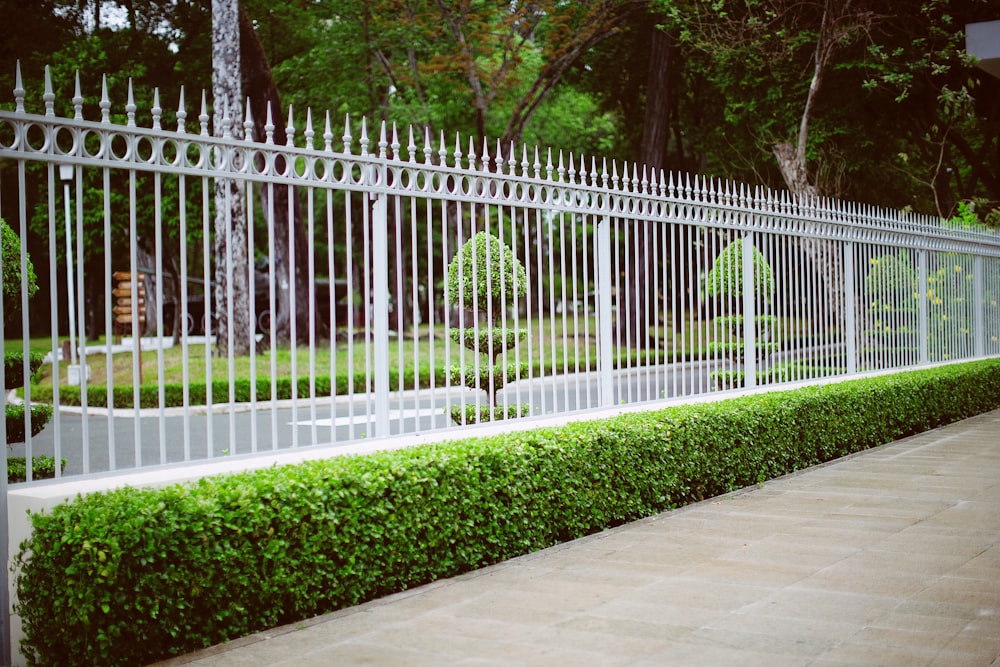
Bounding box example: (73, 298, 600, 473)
(448, 232, 531, 424)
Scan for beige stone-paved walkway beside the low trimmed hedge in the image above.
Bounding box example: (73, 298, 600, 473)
(163, 411, 1000, 667)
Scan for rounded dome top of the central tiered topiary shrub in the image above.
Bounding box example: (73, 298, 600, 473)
(448, 232, 528, 317)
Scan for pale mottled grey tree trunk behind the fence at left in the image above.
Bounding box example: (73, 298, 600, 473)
(212, 0, 254, 356)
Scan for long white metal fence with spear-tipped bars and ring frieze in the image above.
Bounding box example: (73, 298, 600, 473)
(0, 66, 1000, 481)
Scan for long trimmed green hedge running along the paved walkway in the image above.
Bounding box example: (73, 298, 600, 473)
(15, 360, 1000, 666)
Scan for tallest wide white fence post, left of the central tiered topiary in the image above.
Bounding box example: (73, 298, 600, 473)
(372, 188, 389, 438)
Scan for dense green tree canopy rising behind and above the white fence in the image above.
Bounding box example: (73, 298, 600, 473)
(0, 0, 1000, 342)
